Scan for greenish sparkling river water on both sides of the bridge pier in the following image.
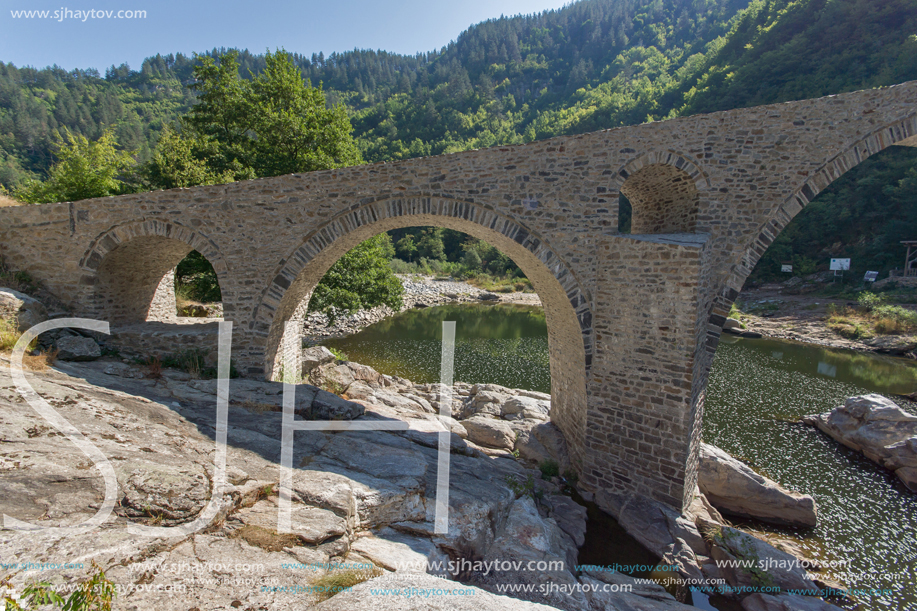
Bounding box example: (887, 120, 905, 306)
(325, 304, 917, 611)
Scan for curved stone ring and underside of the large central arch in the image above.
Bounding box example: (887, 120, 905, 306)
(254, 196, 592, 468)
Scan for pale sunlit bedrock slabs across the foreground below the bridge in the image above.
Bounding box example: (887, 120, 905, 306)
(0, 349, 844, 611)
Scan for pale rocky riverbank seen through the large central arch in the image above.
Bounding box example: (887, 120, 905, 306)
(303, 274, 541, 344)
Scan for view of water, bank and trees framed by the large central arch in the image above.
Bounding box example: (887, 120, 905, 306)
(297, 227, 551, 393)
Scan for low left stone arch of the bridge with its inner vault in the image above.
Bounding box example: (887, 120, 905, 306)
(79, 219, 227, 325)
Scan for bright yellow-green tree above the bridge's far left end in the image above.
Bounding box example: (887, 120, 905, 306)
(15, 128, 136, 204)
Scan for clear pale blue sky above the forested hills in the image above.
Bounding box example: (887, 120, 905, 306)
(0, 0, 568, 73)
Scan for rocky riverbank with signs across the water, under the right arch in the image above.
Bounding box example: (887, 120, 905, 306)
(732, 281, 917, 359)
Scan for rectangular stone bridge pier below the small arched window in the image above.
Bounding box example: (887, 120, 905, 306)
(581, 234, 711, 509)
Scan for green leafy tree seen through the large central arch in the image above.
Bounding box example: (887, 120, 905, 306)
(309, 233, 404, 321)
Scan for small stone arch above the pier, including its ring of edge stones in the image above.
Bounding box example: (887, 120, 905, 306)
(614, 151, 710, 234)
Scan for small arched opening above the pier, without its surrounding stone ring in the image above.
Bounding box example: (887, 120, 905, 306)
(619, 163, 698, 234)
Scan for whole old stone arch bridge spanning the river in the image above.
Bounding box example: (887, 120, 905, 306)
(0, 81, 917, 508)
